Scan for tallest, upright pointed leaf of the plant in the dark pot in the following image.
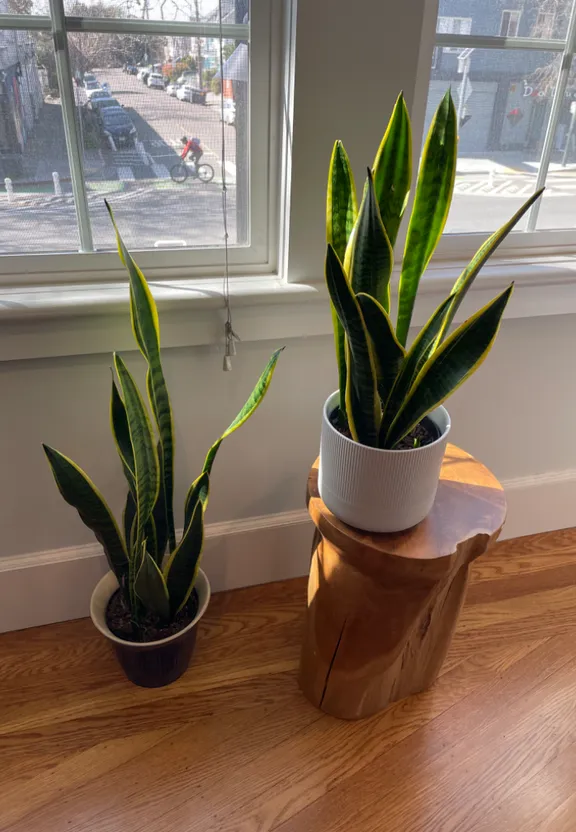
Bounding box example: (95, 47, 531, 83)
(106, 202, 176, 551)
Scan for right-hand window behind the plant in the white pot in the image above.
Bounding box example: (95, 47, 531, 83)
(425, 0, 576, 244)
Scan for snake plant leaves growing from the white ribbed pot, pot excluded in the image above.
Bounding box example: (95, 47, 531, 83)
(326, 92, 542, 448)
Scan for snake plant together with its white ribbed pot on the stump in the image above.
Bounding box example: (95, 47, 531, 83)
(318, 92, 542, 532)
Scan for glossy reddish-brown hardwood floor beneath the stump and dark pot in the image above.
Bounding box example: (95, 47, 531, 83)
(0, 530, 576, 832)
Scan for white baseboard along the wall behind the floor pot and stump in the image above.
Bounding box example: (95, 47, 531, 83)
(0, 469, 576, 632)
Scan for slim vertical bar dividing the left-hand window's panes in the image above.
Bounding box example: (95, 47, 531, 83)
(50, 0, 94, 252)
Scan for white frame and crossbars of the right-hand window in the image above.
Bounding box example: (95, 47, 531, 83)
(416, 0, 576, 263)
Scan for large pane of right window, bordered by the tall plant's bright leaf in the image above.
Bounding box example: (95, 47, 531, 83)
(426, 48, 560, 232)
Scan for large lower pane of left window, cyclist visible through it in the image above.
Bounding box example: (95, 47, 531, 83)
(69, 33, 248, 248)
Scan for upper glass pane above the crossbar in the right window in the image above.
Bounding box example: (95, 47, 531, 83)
(436, 0, 572, 39)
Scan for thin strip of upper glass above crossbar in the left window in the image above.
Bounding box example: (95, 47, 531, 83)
(62, 0, 250, 23)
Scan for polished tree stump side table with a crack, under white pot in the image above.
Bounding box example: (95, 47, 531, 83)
(299, 445, 506, 719)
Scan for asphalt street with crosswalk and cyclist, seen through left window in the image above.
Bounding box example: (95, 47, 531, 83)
(0, 69, 236, 253)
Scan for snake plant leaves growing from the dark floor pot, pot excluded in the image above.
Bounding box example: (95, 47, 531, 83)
(43, 204, 282, 635)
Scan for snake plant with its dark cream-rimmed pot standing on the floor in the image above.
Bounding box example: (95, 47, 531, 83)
(43, 206, 282, 687)
